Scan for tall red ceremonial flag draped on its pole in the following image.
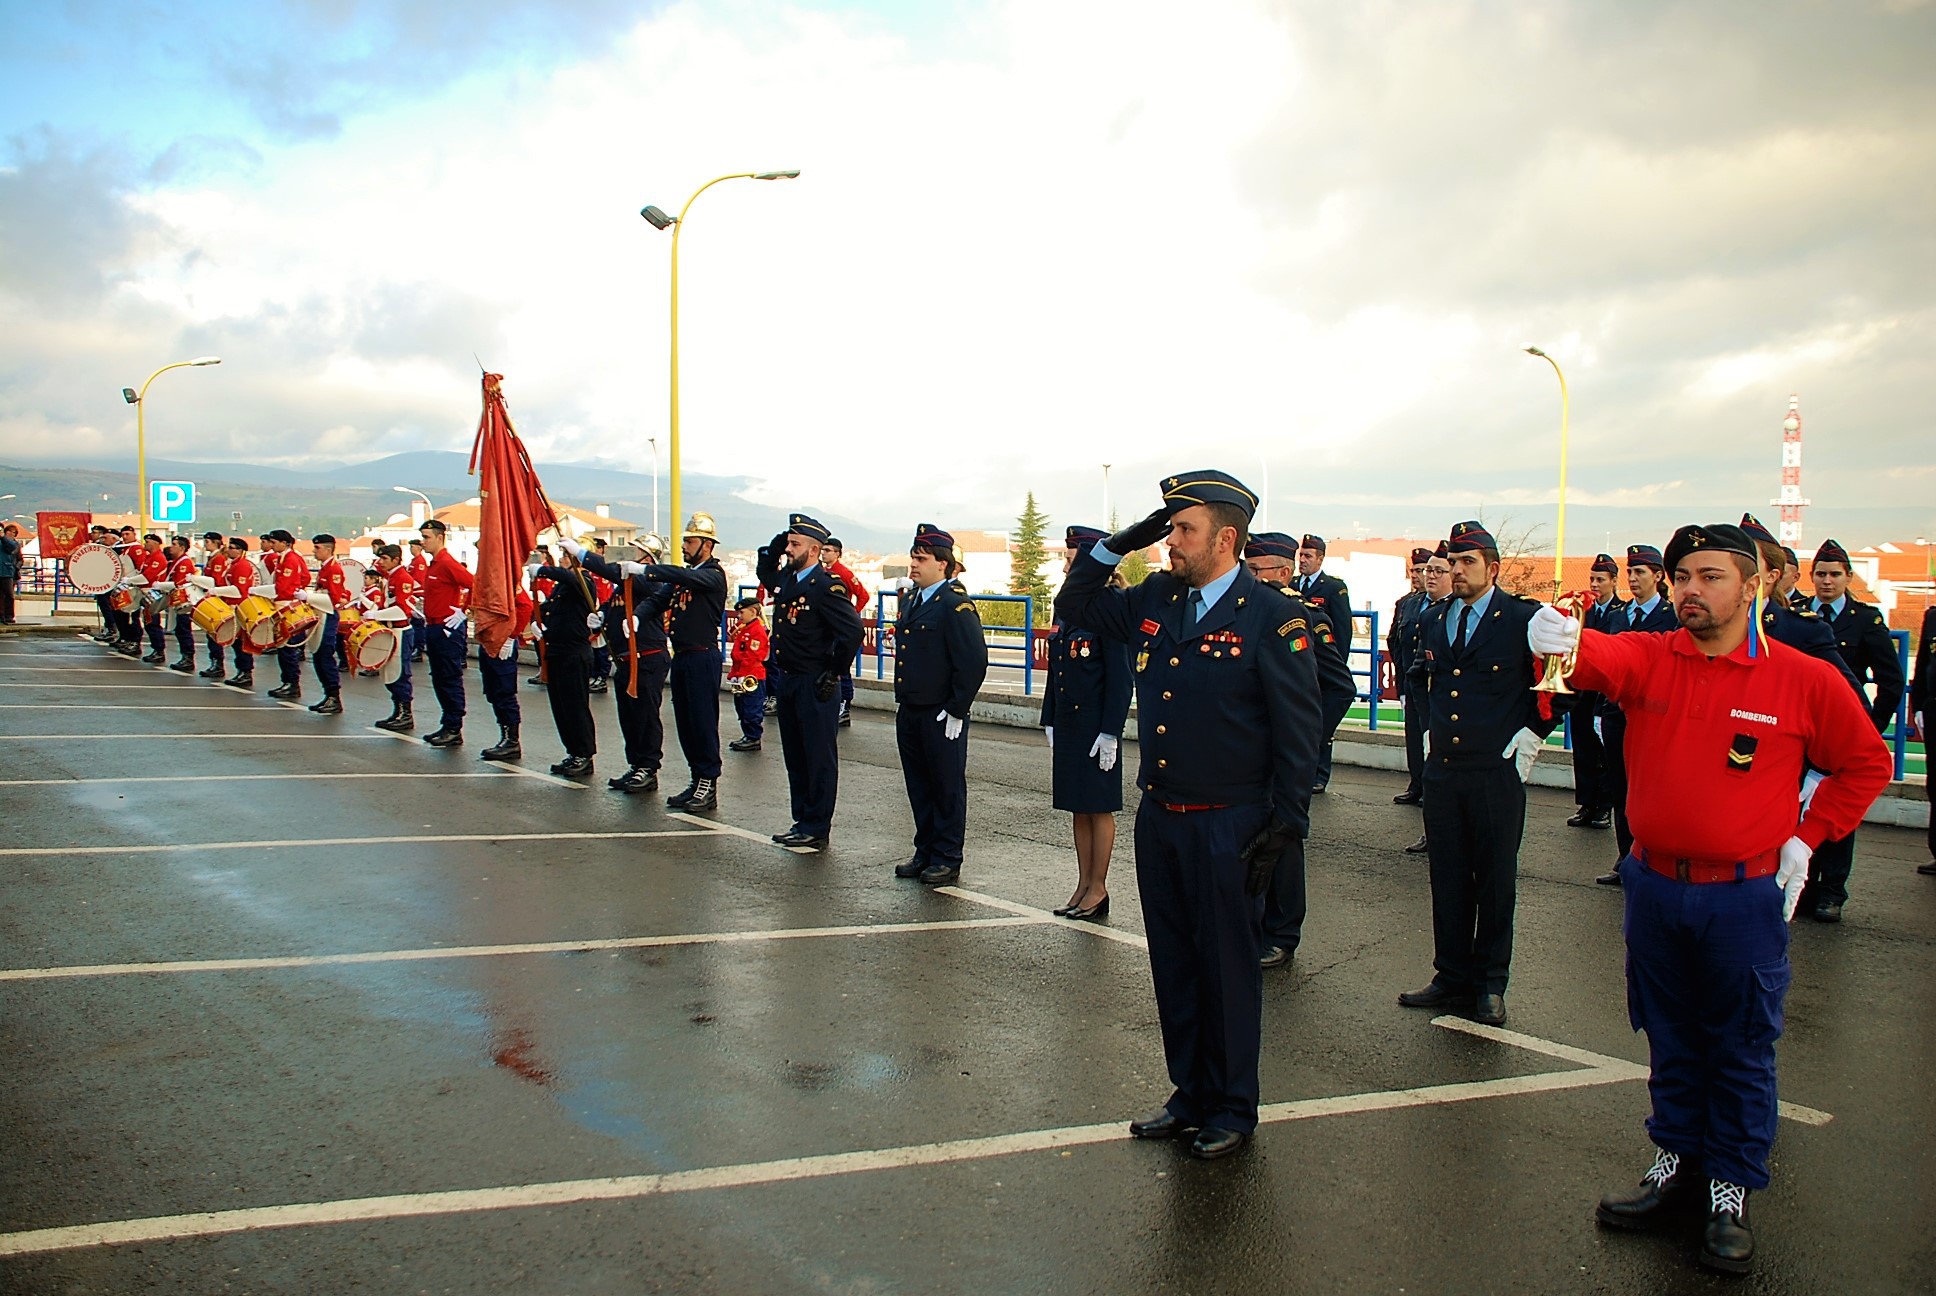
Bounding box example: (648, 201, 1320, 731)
(470, 374, 558, 655)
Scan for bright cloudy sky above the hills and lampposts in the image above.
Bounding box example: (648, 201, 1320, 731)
(0, 0, 1936, 552)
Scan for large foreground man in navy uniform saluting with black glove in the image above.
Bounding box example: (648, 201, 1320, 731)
(1055, 469, 1322, 1160)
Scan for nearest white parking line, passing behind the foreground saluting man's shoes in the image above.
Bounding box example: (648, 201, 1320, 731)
(0, 1046, 1657, 1255)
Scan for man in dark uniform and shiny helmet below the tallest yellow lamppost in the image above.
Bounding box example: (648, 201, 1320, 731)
(623, 513, 726, 810)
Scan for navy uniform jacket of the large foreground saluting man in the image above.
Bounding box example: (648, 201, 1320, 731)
(1055, 554, 1324, 837)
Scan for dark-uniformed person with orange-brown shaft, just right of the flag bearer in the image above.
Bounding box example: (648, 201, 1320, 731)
(569, 533, 672, 794)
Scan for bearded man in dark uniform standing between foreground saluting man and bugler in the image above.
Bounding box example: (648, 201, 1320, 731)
(1398, 521, 1557, 1027)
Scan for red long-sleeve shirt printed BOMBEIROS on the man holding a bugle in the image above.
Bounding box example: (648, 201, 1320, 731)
(1572, 630, 1893, 860)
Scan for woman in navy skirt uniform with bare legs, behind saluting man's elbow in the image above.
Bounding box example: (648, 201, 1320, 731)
(1042, 527, 1131, 920)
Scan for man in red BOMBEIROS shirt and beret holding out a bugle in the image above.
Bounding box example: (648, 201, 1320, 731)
(1526, 523, 1891, 1273)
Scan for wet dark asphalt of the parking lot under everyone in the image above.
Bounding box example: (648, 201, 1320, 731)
(0, 637, 1936, 1294)
